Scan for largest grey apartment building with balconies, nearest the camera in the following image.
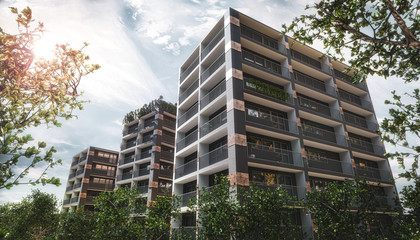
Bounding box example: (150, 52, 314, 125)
(172, 9, 395, 238)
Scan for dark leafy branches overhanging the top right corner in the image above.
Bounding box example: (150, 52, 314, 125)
(283, 0, 420, 82)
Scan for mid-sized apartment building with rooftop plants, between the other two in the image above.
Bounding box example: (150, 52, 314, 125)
(116, 102, 176, 203)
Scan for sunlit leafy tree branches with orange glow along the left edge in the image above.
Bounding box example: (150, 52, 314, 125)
(0, 7, 99, 189)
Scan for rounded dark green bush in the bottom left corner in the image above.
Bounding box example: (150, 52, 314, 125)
(0, 190, 59, 240)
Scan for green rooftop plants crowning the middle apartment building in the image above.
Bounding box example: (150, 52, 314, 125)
(123, 96, 176, 124)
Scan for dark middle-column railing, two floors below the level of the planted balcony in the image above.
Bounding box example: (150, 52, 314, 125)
(305, 157, 353, 175)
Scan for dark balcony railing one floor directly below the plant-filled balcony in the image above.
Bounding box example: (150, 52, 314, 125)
(245, 108, 298, 134)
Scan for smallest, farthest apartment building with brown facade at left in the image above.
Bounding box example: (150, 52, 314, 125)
(63, 146, 118, 211)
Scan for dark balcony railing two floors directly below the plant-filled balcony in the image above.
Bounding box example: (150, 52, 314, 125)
(248, 143, 303, 167)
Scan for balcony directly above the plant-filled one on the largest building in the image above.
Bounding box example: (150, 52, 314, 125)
(242, 49, 290, 78)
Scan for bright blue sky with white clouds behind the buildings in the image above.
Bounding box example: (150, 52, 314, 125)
(0, 0, 420, 204)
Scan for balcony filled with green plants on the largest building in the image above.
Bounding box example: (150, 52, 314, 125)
(244, 77, 293, 104)
